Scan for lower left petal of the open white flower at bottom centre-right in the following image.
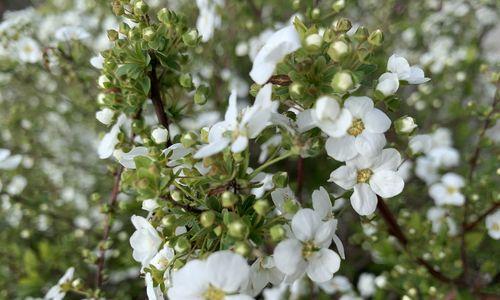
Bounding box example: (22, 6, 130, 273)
(273, 239, 305, 275)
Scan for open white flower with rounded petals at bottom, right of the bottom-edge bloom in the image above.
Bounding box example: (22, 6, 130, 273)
(274, 208, 340, 282)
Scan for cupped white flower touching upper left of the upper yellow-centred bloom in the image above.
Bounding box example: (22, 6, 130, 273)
(308, 96, 352, 137)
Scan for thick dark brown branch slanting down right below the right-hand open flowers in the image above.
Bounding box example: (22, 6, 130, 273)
(377, 197, 459, 284)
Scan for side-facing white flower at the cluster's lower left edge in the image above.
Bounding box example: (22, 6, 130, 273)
(130, 215, 162, 267)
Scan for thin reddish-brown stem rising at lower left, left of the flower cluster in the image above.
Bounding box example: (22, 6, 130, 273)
(96, 165, 123, 289)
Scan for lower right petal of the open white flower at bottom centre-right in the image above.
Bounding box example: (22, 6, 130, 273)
(306, 248, 340, 282)
